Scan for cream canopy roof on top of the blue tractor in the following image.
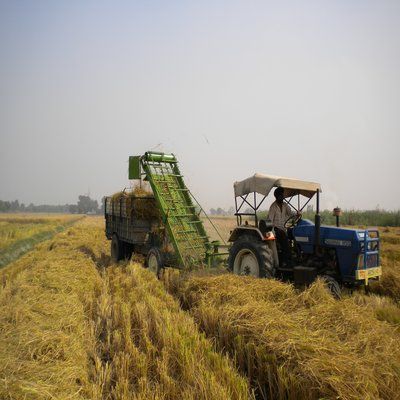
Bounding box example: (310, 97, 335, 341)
(233, 173, 321, 197)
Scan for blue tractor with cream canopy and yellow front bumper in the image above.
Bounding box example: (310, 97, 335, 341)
(228, 174, 382, 297)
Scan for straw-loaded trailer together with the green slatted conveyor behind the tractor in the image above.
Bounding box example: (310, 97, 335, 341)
(104, 152, 227, 273)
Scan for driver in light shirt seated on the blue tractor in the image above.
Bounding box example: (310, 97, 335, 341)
(268, 187, 296, 267)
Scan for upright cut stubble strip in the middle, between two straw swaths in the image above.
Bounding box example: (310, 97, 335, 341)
(93, 264, 253, 400)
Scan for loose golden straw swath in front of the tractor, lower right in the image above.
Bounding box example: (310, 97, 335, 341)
(165, 274, 400, 399)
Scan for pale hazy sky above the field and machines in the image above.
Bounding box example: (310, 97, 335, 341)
(0, 0, 400, 209)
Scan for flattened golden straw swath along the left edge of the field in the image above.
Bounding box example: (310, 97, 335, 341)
(0, 219, 101, 399)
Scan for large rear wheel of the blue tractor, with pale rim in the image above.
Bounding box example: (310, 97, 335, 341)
(228, 235, 274, 278)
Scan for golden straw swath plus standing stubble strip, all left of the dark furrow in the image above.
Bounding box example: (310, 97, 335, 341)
(0, 218, 252, 400)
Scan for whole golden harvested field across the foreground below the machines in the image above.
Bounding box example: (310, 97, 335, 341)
(0, 217, 400, 400)
